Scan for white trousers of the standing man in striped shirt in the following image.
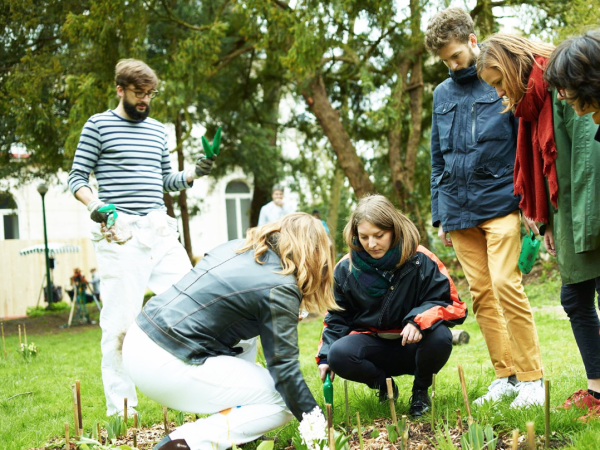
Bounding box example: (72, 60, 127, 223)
(92, 212, 192, 416)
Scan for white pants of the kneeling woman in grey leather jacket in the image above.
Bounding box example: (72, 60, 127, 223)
(123, 324, 293, 450)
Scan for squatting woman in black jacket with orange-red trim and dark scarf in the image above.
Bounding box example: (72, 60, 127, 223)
(317, 195, 467, 417)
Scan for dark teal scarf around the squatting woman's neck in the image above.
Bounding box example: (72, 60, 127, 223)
(350, 241, 402, 297)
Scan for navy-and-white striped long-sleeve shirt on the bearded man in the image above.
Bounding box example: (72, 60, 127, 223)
(69, 110, 192, 215)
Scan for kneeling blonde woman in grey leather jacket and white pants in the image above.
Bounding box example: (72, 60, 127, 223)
(123, 213, 335, 450)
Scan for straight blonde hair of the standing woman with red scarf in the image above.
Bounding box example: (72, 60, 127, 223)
(476, 33, 554, 113)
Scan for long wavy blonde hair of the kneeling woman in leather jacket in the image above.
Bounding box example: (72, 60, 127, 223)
(237, 213, 339, 312)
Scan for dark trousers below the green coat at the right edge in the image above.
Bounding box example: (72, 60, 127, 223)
(560, 277, 600, 380)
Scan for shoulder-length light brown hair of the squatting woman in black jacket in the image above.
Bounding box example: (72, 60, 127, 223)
(344, 195, 421, 267)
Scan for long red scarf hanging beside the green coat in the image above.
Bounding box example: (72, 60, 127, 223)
(514, 56, 558, 223)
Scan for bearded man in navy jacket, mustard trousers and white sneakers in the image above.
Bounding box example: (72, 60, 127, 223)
(425, 8, 544, 407)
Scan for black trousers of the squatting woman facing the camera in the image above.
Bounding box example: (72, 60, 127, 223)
(327, 325, 452, 390)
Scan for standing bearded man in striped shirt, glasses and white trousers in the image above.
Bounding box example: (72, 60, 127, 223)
(69, 59, 213, 415)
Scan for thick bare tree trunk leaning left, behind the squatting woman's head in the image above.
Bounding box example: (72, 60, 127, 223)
(302, 76, 374, 198)
